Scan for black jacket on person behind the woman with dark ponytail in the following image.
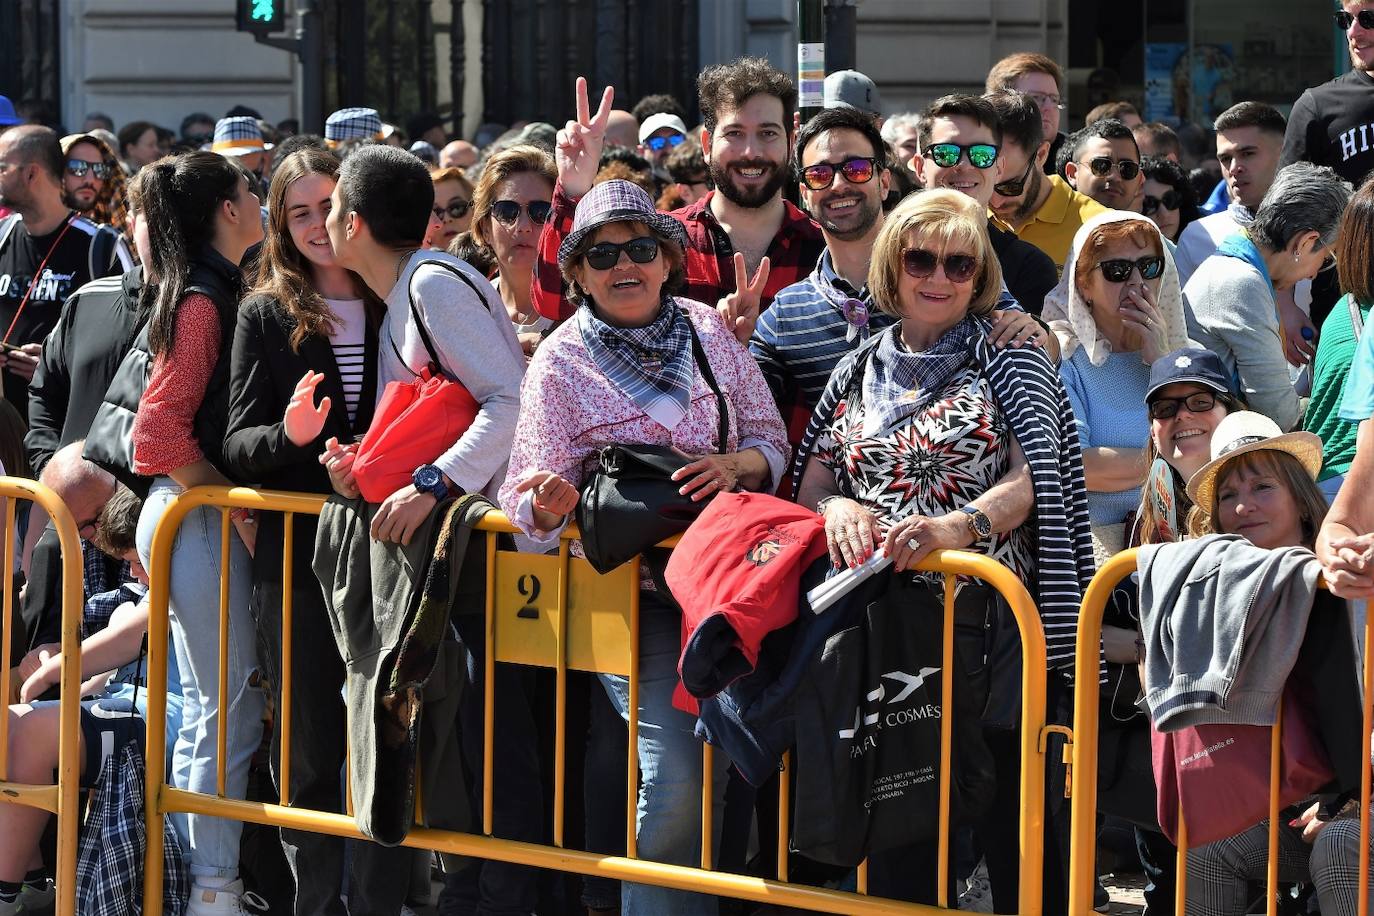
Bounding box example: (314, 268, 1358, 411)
(23, 268, 153, 477)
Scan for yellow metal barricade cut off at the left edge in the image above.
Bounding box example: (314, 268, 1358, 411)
(0, 477, 84, 916)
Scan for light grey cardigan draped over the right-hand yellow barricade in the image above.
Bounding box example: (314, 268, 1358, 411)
(1138, 534, 1320, 732)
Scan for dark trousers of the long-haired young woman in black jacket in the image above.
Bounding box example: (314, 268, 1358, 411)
(253, 585, 414, 916)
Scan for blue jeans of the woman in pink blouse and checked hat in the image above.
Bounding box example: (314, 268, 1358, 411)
(600, 592, 730, 916)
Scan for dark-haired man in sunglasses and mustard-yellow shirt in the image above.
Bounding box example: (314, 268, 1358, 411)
(982, 89, 1110, 273)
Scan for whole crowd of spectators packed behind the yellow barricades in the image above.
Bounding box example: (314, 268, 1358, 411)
(0, 0, 1374, 916)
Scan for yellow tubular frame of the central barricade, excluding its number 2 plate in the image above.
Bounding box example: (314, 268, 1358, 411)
(143, 486, 1068, 916)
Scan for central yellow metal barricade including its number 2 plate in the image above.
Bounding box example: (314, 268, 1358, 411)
(144, 488, 1066, 916)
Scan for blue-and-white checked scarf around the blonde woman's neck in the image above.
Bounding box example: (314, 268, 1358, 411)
(863, 316, 978, 438)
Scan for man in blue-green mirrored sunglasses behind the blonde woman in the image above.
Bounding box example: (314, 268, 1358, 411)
(912, 95, 1058, 315)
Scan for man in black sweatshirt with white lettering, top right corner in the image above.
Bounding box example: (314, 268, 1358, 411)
(1279, 0, 1374, 327)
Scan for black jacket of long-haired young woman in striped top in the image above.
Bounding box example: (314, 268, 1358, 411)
(223, 295, 376, 581)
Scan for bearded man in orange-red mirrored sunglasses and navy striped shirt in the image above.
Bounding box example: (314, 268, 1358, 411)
(749, 108, 1038, 445)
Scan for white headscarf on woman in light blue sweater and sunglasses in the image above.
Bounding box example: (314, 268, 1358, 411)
(1040, 210, 1189, 365)
